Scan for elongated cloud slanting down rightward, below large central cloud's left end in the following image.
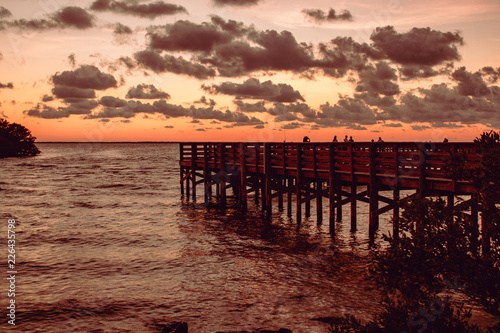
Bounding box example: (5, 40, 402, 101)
(134, 50, 216, 79)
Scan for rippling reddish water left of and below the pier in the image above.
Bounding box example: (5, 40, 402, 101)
(0, 144, 398, 332)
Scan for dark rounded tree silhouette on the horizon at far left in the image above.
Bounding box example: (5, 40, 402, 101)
(0, 118, 40, 158)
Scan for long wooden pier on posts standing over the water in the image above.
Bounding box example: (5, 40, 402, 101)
(179, 142, 484, 238)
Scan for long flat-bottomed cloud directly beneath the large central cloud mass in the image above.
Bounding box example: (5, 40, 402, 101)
(202, 78, 305, 103)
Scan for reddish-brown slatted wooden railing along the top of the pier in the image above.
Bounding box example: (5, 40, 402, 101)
(180, 142, 480, 193)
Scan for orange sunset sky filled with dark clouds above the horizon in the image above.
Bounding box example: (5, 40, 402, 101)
(0, 0, 500, 141)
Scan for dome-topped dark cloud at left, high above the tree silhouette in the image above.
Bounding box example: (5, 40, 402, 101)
(52, 65, 118, 90)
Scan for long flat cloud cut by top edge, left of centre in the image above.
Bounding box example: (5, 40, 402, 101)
(90, 0, 187, 19)
